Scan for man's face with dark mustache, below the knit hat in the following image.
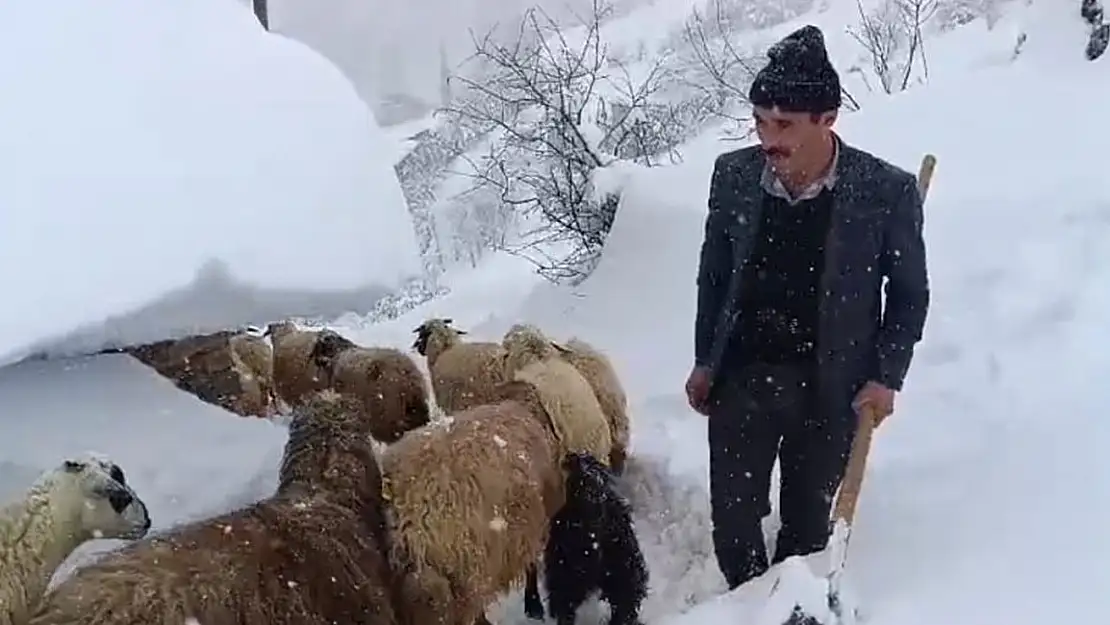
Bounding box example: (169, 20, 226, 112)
(753, 107, 836, 172)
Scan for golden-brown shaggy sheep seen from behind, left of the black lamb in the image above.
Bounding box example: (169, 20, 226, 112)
(382, 382, 566, 625)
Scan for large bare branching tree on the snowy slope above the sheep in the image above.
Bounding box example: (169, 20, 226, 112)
(445, 0, 666, 283)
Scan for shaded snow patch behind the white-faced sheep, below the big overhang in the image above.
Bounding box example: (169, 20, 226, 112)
(0, 355, 286, 578)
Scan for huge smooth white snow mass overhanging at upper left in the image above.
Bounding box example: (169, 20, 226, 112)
(0, 0, 420, 364)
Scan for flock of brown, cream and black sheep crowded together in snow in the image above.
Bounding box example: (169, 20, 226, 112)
(0, 319, 648, 625)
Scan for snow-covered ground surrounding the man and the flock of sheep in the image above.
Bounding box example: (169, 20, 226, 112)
(0, 0, 1110, 625)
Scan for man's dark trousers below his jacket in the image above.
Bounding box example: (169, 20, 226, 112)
(709, 364, 856, 588)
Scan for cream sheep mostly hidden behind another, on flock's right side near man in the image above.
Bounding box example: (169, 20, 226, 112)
(553, 337, 632, 475)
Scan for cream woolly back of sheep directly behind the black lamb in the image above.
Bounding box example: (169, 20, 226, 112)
(513, 359, 613, 470)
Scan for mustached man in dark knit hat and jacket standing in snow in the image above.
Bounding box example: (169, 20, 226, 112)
(686, 26, 929, 588)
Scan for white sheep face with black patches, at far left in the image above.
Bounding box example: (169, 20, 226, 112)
(54, 456, 151, 540)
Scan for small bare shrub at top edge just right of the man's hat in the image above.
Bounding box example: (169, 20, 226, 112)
(848, 0, 937, 93)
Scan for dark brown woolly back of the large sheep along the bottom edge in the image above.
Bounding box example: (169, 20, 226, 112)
(30, 495, 397, 625)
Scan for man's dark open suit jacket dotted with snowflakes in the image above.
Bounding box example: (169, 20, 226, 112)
(695, 141, 929, 402)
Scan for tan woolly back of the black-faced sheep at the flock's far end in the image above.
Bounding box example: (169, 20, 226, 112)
(428, 342, 505, 414)
